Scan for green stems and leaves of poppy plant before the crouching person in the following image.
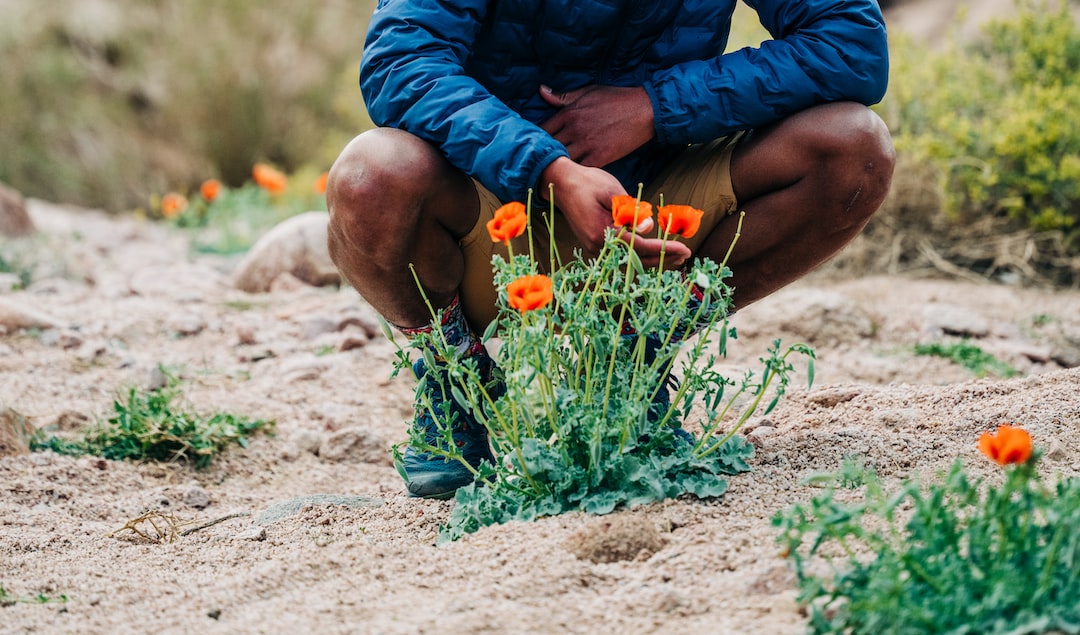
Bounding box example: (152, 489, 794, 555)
(397, 203, 813, 539)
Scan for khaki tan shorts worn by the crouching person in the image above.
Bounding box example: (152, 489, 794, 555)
(460, 133, 743, 333)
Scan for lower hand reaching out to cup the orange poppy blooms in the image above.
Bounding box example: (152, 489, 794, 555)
(539, 157, 690, 268)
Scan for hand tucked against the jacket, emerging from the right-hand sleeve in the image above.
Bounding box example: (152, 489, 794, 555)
(540, 85, 656, 167)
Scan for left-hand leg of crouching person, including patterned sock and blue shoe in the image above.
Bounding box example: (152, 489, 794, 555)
(326, 129, 498, 498)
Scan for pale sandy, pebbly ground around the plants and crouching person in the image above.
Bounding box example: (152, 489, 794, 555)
(0, 201, 1080, 634)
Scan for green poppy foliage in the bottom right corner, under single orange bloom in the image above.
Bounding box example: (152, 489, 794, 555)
(773, 457, 1080, 635)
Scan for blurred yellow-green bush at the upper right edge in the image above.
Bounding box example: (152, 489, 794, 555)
(881, 0, 1080, 249)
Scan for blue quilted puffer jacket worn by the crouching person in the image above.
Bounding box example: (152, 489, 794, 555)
(360, 0, 888, 201)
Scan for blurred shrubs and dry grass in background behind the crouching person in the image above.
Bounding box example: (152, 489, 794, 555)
(0, 0, 1080, 286)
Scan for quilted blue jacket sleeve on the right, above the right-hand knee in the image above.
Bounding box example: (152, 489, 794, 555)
(645, 0, 889, 144)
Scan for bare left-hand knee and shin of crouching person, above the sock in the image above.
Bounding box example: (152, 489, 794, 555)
(326, 129, 478, 327)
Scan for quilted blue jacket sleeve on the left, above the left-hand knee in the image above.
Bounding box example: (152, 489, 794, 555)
(360, 0, 567, 201)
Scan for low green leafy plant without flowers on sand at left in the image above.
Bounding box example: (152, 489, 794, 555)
(30, 369, 274, 468)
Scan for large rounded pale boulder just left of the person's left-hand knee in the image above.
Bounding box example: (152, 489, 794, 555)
(233, 212, 341, 293)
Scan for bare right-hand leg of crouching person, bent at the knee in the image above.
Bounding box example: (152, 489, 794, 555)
(696, 104, 895, 308)
